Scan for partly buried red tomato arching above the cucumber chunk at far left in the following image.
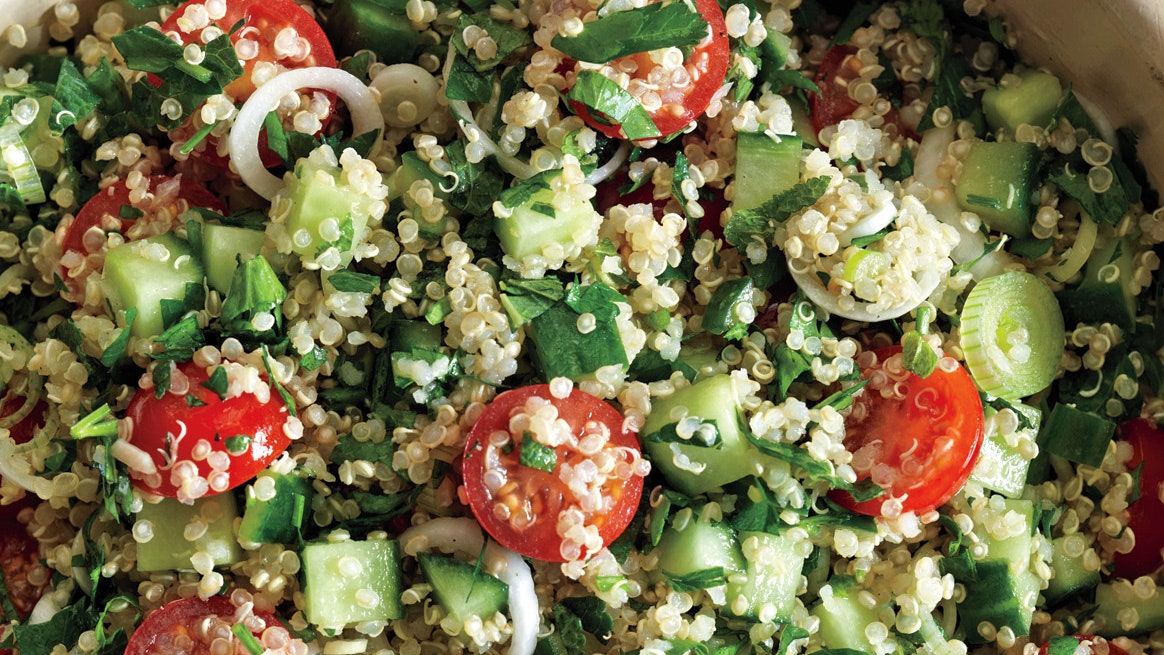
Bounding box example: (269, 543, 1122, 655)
(56, 175, 226, 305)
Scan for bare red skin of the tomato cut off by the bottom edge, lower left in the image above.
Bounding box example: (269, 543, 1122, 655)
(126, 596, 281, 655)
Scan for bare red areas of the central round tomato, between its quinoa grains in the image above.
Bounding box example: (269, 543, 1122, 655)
(462, 384, 643, 562)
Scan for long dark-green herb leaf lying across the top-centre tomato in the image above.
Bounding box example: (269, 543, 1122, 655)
(551, 1, 708, 64)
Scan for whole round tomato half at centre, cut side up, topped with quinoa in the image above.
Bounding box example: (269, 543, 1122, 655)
(462, 384, 645, 562)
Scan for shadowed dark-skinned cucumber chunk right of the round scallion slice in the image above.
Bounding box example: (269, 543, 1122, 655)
(1059, 238, 1136, 329)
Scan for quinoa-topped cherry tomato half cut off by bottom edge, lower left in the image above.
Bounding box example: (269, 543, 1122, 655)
(126, 596, 292, 655)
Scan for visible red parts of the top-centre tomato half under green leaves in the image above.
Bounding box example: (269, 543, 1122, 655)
(570, 0, 731, 138)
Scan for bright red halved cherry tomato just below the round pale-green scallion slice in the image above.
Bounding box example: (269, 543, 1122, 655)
(830, 346, 985, 517)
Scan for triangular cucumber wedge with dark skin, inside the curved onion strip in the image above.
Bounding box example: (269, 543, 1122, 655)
(417, 553, 509, 624)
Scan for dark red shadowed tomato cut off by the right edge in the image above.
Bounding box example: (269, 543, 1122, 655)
(1115, 419, 1164, 579)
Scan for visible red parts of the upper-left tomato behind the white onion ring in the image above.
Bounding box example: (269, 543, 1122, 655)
(151, 0, 336, 169)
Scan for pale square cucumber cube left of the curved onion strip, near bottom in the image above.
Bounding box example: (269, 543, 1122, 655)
(299, 539, 404, 629)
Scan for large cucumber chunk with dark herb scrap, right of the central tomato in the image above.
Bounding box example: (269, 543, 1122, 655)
(640, 373, 759, 496)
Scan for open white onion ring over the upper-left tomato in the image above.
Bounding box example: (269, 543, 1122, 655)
(229, 66, 384, 200)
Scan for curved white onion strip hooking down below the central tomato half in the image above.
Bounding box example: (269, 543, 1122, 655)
(399, 518, 541, 655)
